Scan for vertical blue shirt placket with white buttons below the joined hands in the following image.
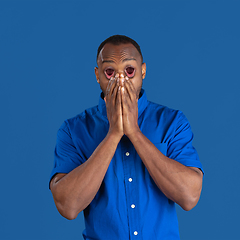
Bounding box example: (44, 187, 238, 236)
(122, 138, 141, 240)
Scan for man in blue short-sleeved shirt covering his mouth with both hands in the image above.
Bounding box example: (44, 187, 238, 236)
(50, 35, 203, 240)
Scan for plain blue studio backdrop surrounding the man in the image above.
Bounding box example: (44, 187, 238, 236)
(0, 0, 240, 240)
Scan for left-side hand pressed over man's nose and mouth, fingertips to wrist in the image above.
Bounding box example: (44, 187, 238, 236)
(104, 75, 124, 138)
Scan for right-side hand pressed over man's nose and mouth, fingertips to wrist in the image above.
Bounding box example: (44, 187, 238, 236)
(121, 77, 140, 138)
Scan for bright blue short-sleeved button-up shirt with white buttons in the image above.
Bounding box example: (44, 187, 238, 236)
(51, 90, 202, 240)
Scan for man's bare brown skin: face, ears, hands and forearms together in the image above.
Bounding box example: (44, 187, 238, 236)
(50, 43, 203, 219)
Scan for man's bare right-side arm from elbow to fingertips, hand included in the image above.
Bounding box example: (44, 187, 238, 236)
(122, 78, 202, 210)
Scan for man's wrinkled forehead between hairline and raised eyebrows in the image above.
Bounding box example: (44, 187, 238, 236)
(98, 43, 141, 62)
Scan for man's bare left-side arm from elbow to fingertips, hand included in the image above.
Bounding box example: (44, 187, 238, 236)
(50, 77, 123, 219)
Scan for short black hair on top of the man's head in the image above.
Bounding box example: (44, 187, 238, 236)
(97, 35, 143, 62)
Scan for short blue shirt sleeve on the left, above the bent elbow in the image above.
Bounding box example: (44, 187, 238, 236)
(49, 121, 83, 187)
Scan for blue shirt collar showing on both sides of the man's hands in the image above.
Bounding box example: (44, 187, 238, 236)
(98, 89, 148, 118)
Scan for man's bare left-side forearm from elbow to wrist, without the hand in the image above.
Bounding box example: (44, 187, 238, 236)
(50, 134, 122, 219)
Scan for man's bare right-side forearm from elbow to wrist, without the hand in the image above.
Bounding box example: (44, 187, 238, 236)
(129, 132, 202, 210)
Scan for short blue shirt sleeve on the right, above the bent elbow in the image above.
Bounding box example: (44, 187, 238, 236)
(167, 111, 204, 173)
